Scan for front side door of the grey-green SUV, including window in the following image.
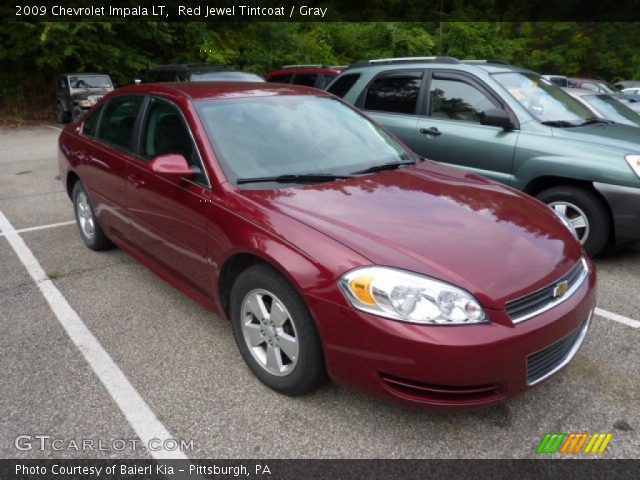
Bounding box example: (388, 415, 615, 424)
(415, 70, 519, 184)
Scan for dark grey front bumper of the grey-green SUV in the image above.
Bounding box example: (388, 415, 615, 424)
(593, 183, 640, 242)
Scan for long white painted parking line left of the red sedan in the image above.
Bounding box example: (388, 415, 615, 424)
(0, 211, 187, 460)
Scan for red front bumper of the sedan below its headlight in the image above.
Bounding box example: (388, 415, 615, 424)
(307, 264, 596, 409)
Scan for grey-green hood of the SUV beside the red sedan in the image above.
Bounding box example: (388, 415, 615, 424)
(553, 124, 640, 153)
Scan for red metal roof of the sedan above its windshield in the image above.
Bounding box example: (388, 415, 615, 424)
(110, 82, 329, 100)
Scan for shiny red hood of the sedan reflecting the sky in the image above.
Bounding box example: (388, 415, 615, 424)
(242, 162, 582, 309)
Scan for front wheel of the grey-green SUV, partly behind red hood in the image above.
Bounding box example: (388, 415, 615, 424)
(537, 185, 611, 256)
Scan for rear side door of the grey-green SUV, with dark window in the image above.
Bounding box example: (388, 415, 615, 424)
(356, 70, 424, 148)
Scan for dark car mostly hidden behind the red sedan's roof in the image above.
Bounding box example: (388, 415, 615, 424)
(135, 63, 264, 83)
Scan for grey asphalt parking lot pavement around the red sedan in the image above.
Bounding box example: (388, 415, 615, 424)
(0, 128, 640, 458)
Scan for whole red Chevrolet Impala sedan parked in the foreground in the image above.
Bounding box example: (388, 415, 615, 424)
(59, 83, 596, 408)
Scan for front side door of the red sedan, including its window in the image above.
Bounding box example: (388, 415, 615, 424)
(127, 97, 214, 292)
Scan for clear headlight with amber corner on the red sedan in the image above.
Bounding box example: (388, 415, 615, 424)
(340, 267, 487, 325)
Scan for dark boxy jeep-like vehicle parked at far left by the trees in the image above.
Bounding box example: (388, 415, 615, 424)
(56, 73, 113, 123)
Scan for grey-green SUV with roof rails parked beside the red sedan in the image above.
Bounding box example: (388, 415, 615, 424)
(327, 57, 640, 255)
